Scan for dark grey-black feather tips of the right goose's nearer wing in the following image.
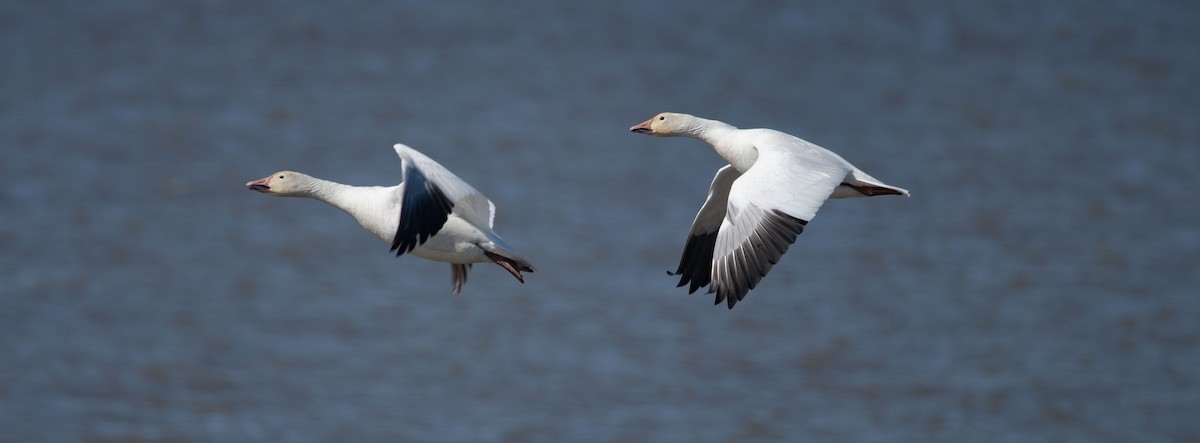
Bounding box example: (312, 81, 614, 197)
(708, 208, 809, 310)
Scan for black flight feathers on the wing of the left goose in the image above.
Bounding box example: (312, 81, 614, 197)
(390, 164, 454, 256)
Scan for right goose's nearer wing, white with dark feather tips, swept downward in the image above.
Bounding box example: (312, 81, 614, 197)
(708, 139, 850, 309)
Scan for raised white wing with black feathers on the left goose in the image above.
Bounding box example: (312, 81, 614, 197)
(391, 143, 496, 255)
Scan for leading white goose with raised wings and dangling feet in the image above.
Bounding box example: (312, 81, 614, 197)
(246, 143, 533, 294)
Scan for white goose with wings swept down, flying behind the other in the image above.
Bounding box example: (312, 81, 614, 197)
(629, 113, 908, 309)
